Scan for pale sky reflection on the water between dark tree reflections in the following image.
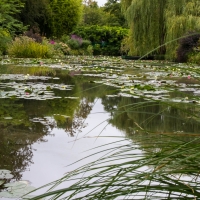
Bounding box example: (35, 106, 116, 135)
(22, 100, 135, 190)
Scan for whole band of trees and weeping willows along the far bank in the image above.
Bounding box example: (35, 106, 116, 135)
(0, 0, 200, 62)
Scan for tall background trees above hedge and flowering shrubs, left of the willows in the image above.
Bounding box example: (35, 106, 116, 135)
(0, 0, 126, 38)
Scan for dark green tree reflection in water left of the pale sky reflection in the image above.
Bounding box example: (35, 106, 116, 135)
(0, 75, 79, 180)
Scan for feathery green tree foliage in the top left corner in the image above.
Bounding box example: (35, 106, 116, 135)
(0, 0, 26, 35)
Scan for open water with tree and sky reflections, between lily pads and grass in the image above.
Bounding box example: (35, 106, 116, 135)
(0, 65, 200, 196)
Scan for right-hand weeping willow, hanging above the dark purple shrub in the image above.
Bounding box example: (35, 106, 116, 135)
(165, 0, 200, 59)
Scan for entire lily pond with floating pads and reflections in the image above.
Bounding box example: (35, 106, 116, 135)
(0, 56, 200, 199)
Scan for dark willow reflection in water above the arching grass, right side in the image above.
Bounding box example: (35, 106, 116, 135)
(103, 97, 200, 134)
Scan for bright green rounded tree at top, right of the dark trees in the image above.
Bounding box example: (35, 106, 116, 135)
(49, 0, 82, 38)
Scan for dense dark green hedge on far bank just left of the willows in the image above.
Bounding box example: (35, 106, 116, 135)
(73, 25, 128, 55)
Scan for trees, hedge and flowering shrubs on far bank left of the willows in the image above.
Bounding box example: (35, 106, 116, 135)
(0, 0, 127, 57)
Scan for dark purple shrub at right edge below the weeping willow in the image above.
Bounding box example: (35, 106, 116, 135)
(177, 32, 200, 62)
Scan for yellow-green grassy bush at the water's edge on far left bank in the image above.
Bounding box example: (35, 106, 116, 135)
(8, 36, 53, 58)
